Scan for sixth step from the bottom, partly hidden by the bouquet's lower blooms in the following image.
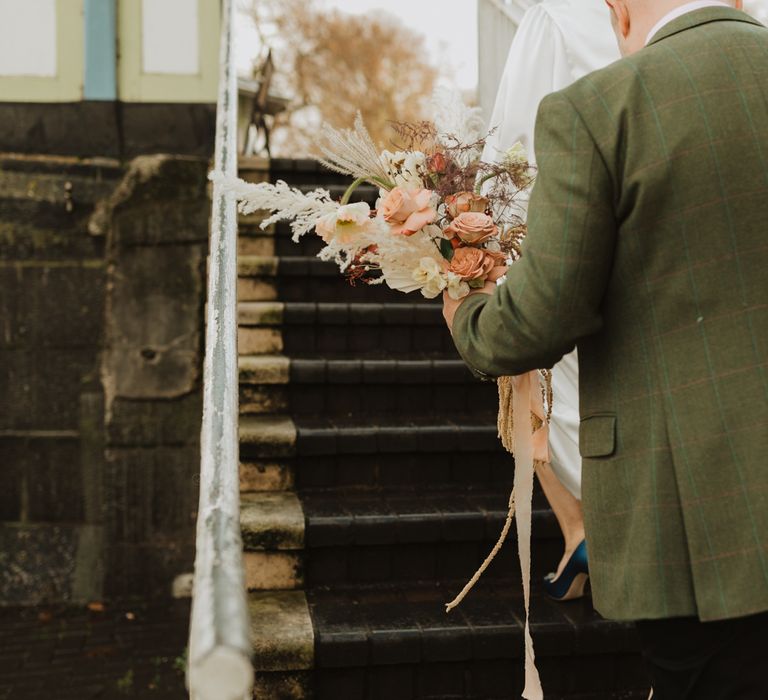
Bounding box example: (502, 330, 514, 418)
(237, 255, 414, 303)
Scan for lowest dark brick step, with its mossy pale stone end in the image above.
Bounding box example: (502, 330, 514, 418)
(252, 581, 648, 700)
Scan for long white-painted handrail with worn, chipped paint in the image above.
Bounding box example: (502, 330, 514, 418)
(187, 0, 253, 700)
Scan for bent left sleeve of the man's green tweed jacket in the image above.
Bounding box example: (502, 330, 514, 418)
(453, 93, 617, 377)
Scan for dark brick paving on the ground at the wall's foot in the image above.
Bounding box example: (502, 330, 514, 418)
(0, 601, 189, 700)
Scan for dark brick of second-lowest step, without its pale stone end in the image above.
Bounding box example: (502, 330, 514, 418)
(300, 490, 562, 591)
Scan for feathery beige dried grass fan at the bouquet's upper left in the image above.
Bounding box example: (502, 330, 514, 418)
(318, 112, 394, 189)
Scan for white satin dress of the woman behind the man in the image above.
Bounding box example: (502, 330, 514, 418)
(483, 0, 620, 499)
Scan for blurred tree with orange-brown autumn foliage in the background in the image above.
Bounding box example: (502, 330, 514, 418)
(250, 0, 438, 157)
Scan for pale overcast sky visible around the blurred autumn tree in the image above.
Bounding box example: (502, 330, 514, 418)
(236, 0, 477, 89)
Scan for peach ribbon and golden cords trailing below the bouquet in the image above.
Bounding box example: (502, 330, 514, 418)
(445, 371, 552, 700)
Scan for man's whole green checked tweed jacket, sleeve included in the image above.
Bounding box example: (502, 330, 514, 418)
(453, 7, 768, 620)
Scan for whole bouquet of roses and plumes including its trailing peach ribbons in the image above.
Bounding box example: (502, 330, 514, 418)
(211, 93, 551, 698)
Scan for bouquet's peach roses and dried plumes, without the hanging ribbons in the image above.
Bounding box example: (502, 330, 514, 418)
(213, 89, 533, 299)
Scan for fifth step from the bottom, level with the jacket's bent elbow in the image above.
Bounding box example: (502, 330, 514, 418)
(238, 301, 458, 358)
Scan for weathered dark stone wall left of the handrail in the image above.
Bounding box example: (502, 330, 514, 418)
(0, 156, 209, 604)
